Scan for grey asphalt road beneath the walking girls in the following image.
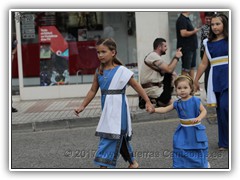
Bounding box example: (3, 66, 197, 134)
(10, 119, 229, 170)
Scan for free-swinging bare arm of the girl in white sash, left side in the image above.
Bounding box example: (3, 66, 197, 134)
(74, 73, 99, 116)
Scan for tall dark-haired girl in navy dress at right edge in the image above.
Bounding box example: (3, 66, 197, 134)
(194, 14, 229, 151)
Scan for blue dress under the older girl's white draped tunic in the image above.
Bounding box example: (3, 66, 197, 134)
(94, 66, 134, 168)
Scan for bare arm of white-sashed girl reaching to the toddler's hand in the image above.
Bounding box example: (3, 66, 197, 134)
(128, 77, 154, 112)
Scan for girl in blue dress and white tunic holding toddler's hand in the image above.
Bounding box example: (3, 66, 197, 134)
(75, 39, 154, 168)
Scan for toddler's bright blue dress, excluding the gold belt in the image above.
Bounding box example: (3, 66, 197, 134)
(173, 96, 208, 168)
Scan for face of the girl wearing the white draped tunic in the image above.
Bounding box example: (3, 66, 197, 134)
(96, 44, 116, 63)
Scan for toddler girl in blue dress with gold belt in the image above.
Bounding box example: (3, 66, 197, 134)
(155, 75, 208, 168)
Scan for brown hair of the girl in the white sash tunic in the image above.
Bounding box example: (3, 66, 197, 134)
(96, 38, 123, 75)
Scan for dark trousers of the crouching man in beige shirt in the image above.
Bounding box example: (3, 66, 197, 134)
(138, 73, 174, 109)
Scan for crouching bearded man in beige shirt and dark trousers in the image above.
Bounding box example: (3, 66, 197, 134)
(139, 38, 182, 109)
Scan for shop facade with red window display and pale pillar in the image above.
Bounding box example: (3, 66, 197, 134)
(10, 10, 214, 100)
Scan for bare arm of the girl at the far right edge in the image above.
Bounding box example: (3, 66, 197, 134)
(194, 52, 209, 91)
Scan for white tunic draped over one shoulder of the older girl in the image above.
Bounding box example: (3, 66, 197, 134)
(96, 66, 133, 139)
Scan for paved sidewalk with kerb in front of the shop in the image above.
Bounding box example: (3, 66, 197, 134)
(11, 89, 214, 131)
